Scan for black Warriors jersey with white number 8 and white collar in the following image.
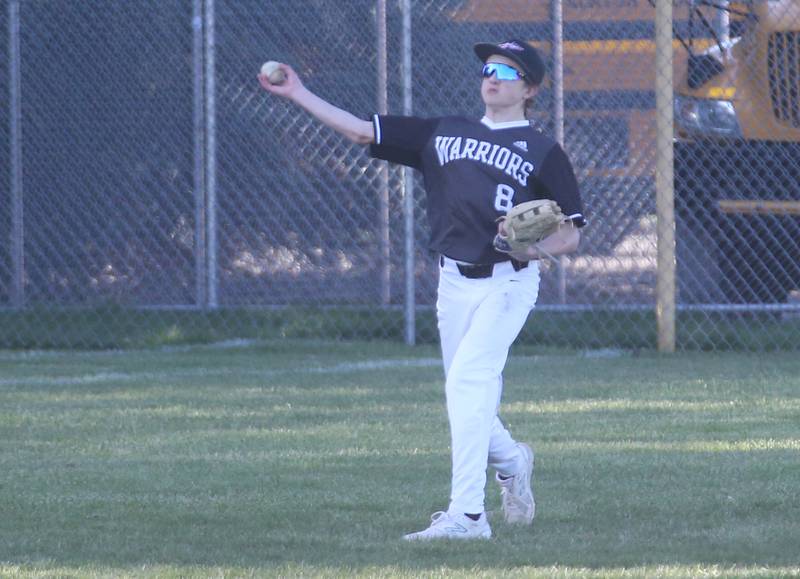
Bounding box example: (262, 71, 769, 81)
(370, 115, 585, 263)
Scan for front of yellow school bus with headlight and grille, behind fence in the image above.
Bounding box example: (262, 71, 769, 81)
(675, 0, 800, 303)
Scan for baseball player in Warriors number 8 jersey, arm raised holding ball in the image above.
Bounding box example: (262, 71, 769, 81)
(259, 40, 584, 541)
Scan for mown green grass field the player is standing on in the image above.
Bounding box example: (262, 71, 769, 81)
(0, 340, 800, 578)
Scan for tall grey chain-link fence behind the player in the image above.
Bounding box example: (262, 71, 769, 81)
(0, 0, 800, 349)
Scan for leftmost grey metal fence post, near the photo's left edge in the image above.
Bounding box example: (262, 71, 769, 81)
(8, 0, 25, 308)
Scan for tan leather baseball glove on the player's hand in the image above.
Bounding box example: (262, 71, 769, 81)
(494, 199, 566, 253)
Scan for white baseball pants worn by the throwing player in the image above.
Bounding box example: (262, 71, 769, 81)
(436, 257, 539, 514)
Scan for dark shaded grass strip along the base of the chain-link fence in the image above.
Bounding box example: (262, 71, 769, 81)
(0, 304, 800, 351)
